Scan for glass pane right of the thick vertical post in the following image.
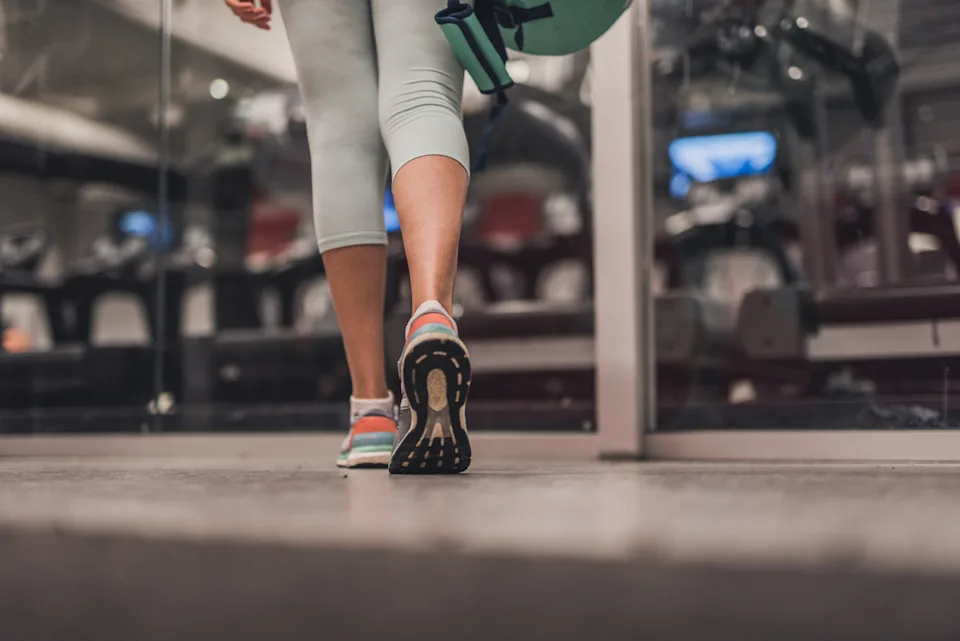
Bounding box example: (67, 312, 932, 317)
(651, 0, 960, 430)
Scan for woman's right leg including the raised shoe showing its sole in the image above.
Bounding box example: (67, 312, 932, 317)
(371, 0, 471, 474)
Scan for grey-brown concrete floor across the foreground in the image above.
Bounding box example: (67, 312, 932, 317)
(0, 459, 960, 641)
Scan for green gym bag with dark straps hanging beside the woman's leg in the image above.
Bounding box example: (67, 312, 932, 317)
(436, 0, 632, 171)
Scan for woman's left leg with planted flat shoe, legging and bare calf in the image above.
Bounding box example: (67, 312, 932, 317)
(280, 0, 393, 464)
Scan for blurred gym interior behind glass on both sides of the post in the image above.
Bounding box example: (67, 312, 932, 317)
(0, 0, 960, 433)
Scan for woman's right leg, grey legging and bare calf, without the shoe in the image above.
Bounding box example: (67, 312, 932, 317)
(372, 0, 470, 312)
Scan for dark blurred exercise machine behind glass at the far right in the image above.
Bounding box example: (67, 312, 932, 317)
(738, 0, 960, 428)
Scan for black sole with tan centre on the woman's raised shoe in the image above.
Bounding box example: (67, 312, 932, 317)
(389, 333, 471, 474)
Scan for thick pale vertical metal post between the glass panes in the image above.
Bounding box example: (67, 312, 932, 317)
(591, 0, 656, 458)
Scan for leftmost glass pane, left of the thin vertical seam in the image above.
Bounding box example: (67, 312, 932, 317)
(0, 0, 162, 433)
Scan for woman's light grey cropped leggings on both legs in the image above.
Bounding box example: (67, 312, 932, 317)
(280, 0, 469, 253)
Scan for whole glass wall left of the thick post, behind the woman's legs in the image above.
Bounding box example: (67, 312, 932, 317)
(0, 0, 593, 433)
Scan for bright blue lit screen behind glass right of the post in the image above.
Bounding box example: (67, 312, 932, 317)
(669, 131, 777, 188)
